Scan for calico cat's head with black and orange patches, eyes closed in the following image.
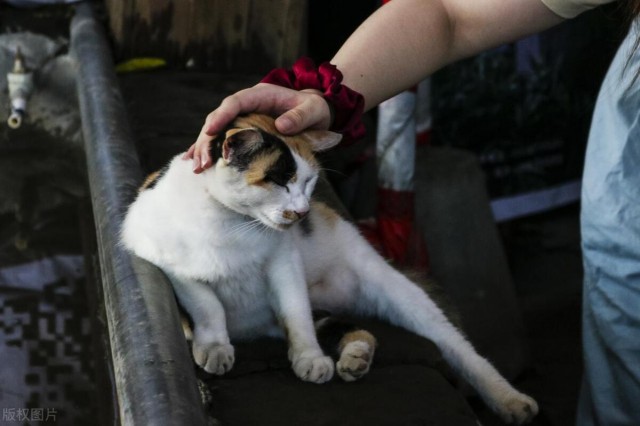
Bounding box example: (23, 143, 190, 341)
(209, 114, 341, 230)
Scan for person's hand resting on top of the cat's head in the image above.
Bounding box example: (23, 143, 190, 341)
(183, 83, 331, 173)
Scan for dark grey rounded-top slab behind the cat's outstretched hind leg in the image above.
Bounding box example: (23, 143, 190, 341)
(415, 147, 527, 378)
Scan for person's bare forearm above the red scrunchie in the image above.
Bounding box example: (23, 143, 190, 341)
(331, 0, 562, 109)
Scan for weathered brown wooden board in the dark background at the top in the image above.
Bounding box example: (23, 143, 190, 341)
(105, 0, 307, 73)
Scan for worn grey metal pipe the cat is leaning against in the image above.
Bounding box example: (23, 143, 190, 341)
(71, 3, 205, 425)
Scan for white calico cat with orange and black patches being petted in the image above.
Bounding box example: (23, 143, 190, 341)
(122, 114, 538, 423)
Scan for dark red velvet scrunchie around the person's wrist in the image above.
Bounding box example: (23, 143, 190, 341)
(260, 58, 365, 140)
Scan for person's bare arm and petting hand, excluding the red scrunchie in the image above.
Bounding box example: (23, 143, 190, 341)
(186, 0, 562, 172)
